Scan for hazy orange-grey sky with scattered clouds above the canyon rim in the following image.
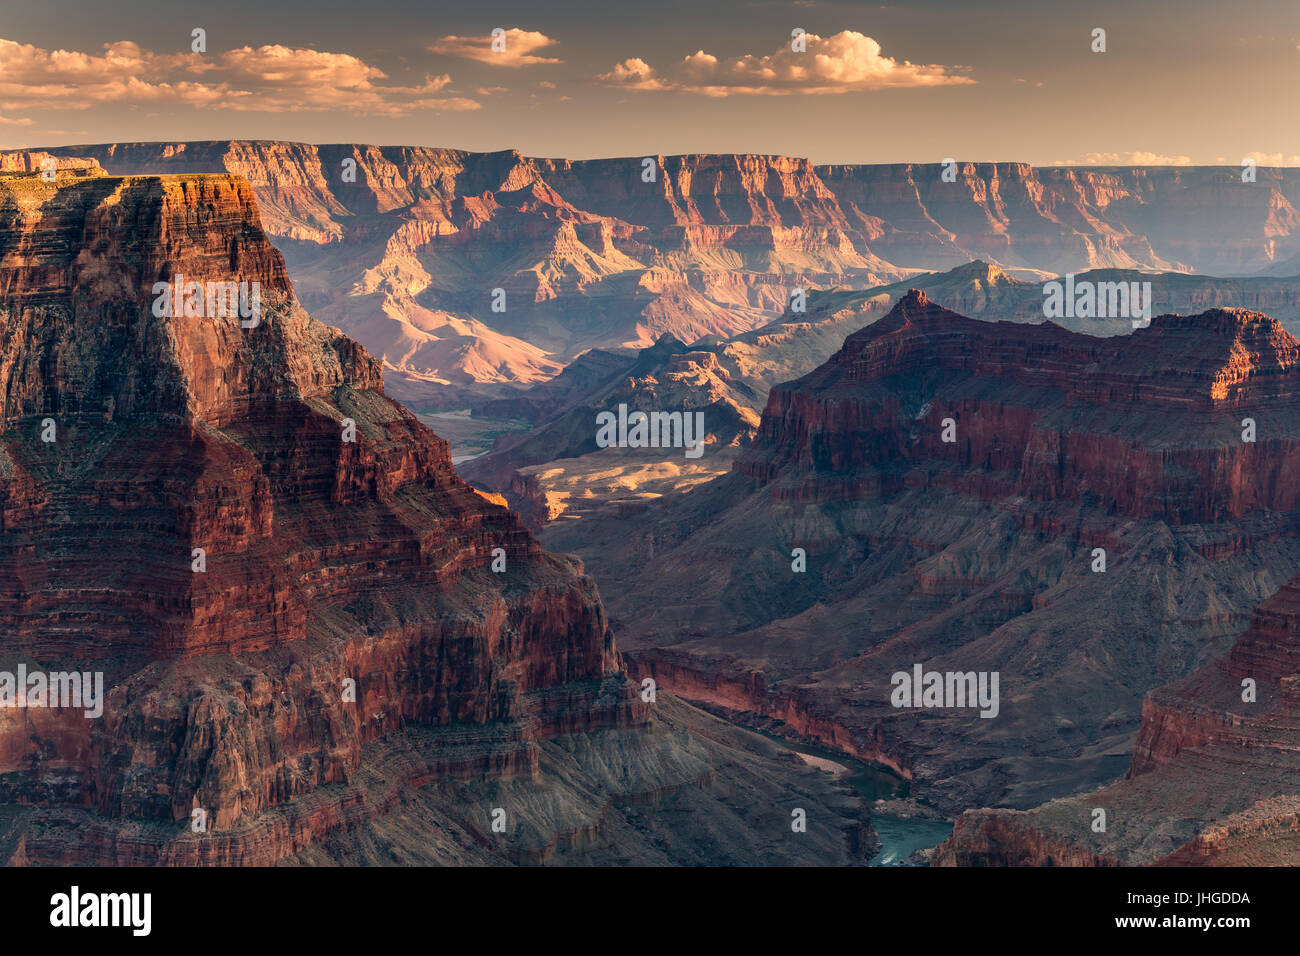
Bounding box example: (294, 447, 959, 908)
(0, 0, 1300, 165)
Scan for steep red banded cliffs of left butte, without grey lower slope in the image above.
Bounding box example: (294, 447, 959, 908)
(0, 167, 629, 862)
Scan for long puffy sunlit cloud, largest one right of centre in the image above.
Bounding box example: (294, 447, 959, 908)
(597, 30, 975, 96)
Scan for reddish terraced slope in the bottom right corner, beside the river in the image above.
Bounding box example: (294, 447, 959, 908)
(937, 567, 1300, 866)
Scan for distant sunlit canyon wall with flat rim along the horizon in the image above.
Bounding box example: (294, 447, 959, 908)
(38, 140, 1300, 407)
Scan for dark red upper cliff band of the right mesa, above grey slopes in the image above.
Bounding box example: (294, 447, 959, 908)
(736, 291, 1300, 524)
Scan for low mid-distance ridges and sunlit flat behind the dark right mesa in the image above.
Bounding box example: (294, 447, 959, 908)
(463, 261, 1300, 529)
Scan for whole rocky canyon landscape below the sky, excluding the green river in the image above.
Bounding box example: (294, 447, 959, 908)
(0, 140, 1300, 866)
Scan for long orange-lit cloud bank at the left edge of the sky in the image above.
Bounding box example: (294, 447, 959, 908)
(0, 39, 480, 117)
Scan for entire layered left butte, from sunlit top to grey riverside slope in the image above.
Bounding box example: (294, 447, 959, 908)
(0, 169, 872, 864)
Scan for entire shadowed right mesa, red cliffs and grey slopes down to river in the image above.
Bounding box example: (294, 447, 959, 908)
(542, 291, 1300, 808)
